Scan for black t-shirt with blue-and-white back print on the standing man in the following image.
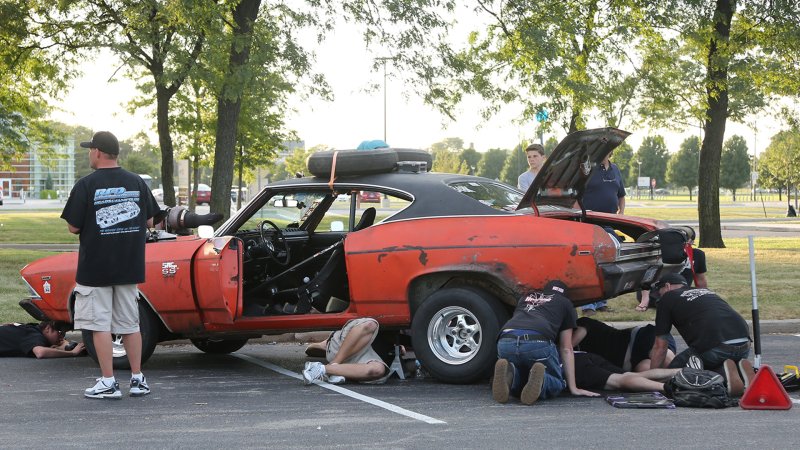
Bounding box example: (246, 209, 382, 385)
(61, 167, 159, 286)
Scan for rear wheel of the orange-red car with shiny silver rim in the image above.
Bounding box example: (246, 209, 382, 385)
(411, 287, 508, 384)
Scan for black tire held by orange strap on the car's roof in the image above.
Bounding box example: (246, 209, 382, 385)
(308, 148, 397, 177)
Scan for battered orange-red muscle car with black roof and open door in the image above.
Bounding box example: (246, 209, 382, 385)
(20, 128, 686, 383)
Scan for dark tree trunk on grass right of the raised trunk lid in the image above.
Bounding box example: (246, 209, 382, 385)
(697, 0, 735, 248)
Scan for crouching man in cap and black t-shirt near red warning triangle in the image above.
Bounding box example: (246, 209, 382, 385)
(650, 273, 750, 372)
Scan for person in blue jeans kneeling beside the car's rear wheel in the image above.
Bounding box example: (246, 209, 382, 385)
(492, 280, 599, 405)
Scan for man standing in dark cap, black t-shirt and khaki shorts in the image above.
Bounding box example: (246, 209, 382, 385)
(61, 131, 159, 398)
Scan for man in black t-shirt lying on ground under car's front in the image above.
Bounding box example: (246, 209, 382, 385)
(0, 321, 84, 359)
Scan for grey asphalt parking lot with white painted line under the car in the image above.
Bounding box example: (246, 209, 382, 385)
(0, 335, 800, 448)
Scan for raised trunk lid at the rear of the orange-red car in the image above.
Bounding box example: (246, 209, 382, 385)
(517, 128, 630, 209)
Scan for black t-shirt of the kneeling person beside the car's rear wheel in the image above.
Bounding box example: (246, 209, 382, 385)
(502, 292, 578, 342)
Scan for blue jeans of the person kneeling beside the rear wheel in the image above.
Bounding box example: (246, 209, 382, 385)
(497, 337, 567, 399)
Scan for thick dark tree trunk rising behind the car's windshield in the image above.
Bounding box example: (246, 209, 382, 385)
(211, 0, 261, 219)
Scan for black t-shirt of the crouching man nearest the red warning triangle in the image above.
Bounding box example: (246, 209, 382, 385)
(656, 288, 750, 353)
